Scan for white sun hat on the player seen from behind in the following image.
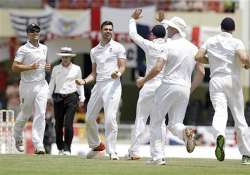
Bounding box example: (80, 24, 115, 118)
(163, 16, 187, 37)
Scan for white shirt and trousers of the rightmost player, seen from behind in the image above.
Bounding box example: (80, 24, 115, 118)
(202, 32, 250, 155)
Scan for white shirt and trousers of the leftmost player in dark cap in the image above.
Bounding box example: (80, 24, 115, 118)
(14, 42, 49, 148)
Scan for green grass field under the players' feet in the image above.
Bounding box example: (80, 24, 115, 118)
(0, 155, 250, 175)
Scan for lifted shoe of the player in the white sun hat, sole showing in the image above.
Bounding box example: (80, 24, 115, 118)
(184, 128, 195, 153)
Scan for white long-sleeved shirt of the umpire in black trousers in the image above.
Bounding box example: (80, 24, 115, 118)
(49, 63, 85, 102)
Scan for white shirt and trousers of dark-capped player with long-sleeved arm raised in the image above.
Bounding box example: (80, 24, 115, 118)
(129, 19, 167, 155)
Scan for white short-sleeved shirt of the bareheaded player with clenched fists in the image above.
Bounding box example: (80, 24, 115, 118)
(90, 39, 126, 81)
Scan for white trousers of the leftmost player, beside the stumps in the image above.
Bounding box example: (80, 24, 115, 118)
(14, 80, 49, 149)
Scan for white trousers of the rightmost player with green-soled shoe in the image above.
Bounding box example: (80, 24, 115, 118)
(209, 76, 250, 156)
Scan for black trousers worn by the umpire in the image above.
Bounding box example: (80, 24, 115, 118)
(53, 92, 78, 151)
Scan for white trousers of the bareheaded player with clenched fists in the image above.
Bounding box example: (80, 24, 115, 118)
(86, 79, 122, 154)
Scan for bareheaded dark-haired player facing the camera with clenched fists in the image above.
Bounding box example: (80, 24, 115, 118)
(76, 21, 126, 160)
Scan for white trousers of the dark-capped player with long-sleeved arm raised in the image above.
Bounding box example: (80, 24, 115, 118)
(128, 79, 166, 155)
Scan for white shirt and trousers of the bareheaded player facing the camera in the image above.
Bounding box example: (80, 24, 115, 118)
(86, 39, 126, 154)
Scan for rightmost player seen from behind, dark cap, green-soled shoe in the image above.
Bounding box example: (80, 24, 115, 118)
(195, 17, 250, 164)
